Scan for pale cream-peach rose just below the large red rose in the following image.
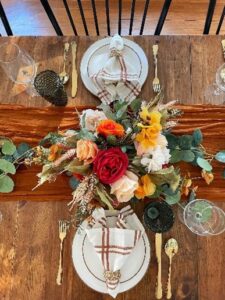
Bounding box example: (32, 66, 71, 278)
(110, 171, 138, 202)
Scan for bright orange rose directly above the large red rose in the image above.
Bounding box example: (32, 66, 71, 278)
(97, 120, 124, 137)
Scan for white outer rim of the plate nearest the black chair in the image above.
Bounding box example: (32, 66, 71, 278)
(80, 37, 149, 96)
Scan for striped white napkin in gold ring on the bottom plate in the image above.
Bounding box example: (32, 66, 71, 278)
(85, 206, 144, 298)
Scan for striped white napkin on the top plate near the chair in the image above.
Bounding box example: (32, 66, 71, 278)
(91, 34, 141, 104)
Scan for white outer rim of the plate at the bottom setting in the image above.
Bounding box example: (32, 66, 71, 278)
(72, 212, 150, 293)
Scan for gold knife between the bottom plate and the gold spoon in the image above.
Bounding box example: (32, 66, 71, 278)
(155, 233, 162, 299)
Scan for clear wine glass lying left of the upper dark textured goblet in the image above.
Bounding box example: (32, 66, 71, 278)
(0, 42, 37, 96)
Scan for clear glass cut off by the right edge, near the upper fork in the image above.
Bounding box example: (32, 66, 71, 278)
(204, 64, 225, 105)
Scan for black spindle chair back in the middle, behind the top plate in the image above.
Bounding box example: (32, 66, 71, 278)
(40, 0, 172, 36)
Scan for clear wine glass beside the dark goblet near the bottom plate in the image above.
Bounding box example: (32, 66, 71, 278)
(179, 199, 225, 236)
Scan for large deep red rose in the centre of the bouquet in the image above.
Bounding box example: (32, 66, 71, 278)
(94, 147, 129, 184)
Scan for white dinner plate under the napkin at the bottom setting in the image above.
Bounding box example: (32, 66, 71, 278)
(72, 211, 150, 293)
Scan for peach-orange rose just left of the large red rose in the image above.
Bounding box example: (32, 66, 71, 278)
(77, 140, 98, 165)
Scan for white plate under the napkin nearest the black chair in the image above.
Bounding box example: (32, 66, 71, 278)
(80, 37, 148, 95)
